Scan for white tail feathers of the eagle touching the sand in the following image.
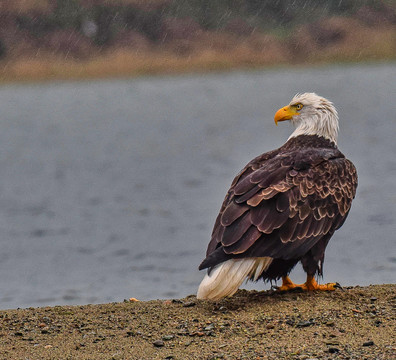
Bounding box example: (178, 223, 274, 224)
(197, 257, 272, 300)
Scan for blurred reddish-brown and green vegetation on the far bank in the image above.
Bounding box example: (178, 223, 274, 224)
(0, 0, 396, 81)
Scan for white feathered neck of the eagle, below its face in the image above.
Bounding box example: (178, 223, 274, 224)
(289, 108, 338, 145)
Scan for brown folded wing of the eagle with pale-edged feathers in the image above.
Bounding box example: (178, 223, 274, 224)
(200, 148, 357, 269)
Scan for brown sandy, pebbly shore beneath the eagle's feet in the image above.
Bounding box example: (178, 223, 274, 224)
(0, 285, 396, 360)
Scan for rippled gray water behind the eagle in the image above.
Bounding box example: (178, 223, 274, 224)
(0, 64, 396, 308)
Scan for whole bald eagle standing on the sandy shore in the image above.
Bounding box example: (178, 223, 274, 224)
(197, 93, 357, 300)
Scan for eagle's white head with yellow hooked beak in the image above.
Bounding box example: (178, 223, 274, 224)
(275, 93, 338, 144)
